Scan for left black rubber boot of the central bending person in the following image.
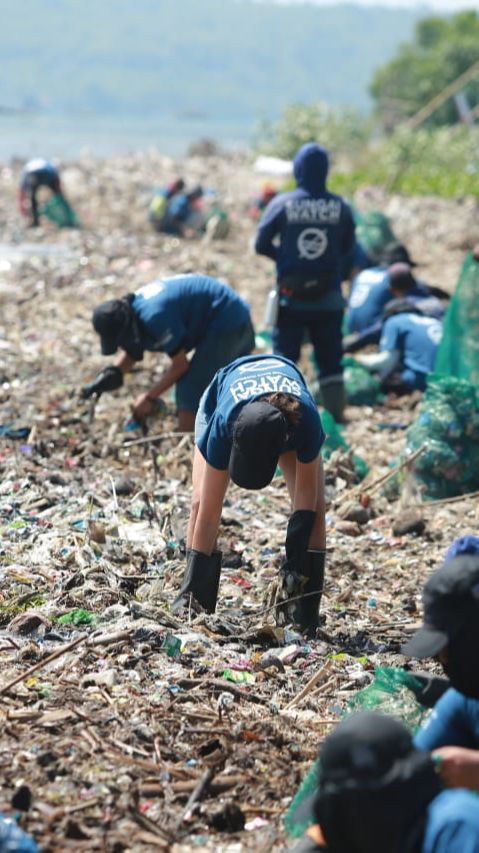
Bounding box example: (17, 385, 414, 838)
(171, 548, 222, 615)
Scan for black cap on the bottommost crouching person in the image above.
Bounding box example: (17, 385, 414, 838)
(318, 711, 414, 793)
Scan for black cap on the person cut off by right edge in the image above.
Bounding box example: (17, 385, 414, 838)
(401, 555, 479, 658)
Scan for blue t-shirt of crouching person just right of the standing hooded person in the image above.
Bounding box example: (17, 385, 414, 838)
(347, 267, 392, 334)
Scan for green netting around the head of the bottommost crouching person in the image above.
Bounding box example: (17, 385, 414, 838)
(284, 666, 428, 838)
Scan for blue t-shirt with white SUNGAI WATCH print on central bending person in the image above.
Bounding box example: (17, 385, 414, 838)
(198, 355, 325, 471)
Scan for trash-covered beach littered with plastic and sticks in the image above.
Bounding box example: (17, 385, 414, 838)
(0, 152, 479, 853)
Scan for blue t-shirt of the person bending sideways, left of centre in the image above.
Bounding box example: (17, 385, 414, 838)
(132, 275, 250, 356)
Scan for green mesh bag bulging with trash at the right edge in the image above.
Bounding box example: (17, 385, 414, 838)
(406, 374, 479, 499)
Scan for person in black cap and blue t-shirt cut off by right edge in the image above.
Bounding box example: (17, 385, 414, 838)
(401, 537, 479, 791)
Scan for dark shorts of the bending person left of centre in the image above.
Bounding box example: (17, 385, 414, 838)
(176, 321, 255, 412)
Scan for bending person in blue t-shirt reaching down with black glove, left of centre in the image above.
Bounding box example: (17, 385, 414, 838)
(82, 274, 254, 432)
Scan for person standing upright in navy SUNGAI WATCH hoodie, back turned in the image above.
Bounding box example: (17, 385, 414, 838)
(255, 143, 354, 421)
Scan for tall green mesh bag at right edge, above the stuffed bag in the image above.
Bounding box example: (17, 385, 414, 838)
(436, 252, 479, 387)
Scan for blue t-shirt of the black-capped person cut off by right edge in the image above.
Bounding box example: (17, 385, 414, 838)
(414, 687, 479, 750)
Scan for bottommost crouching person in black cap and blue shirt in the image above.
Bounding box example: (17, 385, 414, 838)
(294, 712, 479, 853)
